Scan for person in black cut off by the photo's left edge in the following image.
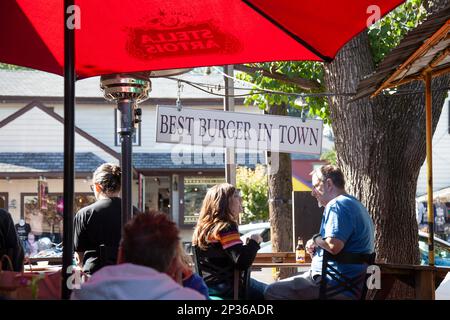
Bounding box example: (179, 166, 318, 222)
(0, 209, 24, 272)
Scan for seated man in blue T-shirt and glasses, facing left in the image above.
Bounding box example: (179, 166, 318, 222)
(265, 165, 374, 300)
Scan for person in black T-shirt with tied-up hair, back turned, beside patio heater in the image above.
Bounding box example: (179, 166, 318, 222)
(74, 163, 122, 274)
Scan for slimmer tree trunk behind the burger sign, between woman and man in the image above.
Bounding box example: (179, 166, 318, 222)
(267, 105, 295, 280)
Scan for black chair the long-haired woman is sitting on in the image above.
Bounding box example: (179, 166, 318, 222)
(192, 246, 250, 300)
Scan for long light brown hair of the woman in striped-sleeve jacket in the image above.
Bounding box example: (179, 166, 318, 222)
(192, 183, 237, 249)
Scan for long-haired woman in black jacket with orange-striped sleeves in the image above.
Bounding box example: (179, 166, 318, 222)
(192, 183, 267, 300)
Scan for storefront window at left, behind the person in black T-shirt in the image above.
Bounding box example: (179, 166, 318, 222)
(22, 194, 95, 243)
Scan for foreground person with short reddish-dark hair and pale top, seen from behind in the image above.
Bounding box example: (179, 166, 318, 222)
(71, 212, 205, 300)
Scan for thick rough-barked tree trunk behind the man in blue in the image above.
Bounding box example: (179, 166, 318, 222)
(325, 1, 450, 299)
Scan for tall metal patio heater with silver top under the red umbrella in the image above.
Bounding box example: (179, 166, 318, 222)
(100, 69, 191, 227)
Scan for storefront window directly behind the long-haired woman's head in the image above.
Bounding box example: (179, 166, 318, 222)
(183, 177, 225, 225)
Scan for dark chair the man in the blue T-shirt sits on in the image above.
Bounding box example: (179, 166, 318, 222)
(319, 250, 376, 300)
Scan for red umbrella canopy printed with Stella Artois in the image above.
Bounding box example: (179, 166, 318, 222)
(0, 0, 404, 79)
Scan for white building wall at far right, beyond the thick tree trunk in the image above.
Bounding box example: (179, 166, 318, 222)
(416, 98, 450, 196)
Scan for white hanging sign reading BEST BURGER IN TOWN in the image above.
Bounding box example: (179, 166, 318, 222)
(156, 106, 323, 155)
